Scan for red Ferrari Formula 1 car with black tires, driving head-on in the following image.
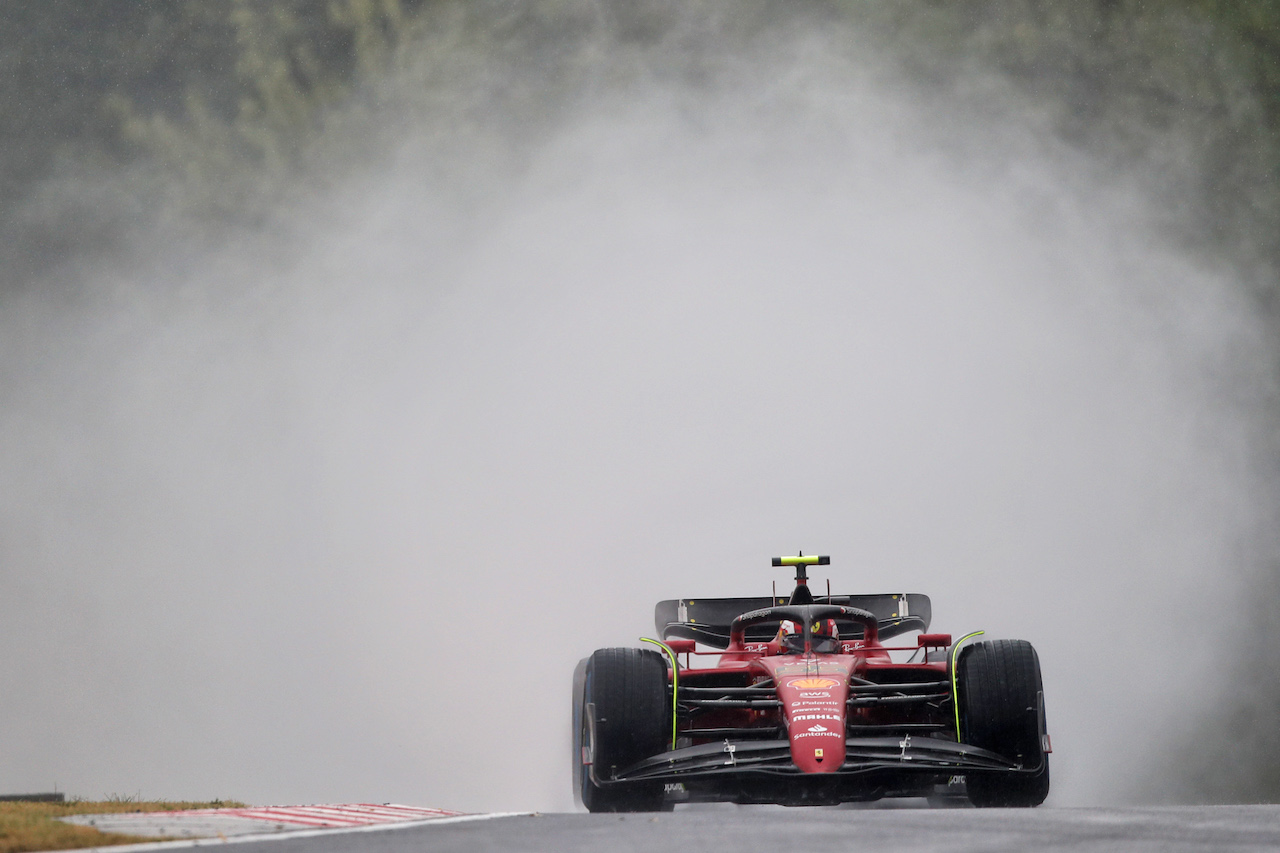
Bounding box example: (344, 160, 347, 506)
(573, 555, 1051, 812)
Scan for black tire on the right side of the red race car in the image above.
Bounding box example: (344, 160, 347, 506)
(956, 640, 1048, 808)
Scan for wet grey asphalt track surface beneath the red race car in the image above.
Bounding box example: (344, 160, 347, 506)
(222, 806, 1280, 853)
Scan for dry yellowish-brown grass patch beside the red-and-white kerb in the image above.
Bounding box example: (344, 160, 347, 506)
(0, 799, 243, 853)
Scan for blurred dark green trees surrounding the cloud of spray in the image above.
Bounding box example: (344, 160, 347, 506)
(0, 0, 1280, 799)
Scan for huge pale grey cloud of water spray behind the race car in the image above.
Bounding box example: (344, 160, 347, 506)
(0, 4, 1272, 809)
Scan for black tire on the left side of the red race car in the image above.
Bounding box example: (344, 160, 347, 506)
(573, 648, 671, 812)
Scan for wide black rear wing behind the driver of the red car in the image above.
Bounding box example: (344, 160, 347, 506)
(654, 593, 933, 648)
